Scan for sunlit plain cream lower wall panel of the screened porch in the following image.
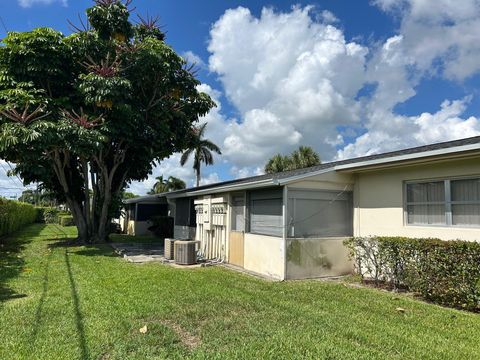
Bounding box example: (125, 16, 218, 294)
(244, 233, 285, 280)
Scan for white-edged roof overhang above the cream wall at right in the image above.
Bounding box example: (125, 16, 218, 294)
(334, 143, 480, 172)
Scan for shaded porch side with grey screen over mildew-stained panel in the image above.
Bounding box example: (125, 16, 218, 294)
(285, 189, 353, 279)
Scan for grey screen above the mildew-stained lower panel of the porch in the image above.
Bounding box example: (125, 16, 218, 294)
(287, 190, 353, 238)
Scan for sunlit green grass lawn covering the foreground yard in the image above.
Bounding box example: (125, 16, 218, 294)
(0, 225, 480, 359)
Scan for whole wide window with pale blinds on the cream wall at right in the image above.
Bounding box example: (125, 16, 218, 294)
(406, 178, 480, 226)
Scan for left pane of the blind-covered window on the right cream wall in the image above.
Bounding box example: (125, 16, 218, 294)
(407, 181, 446, 225)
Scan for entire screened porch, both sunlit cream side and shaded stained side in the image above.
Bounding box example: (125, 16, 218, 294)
(224, 187, 353, 279)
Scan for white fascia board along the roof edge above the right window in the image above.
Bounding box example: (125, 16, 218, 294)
(334, 143, 480, 171)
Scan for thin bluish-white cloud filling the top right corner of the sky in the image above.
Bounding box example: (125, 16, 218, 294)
(375, 0, 480, 80)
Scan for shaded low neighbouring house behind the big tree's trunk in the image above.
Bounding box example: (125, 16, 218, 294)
(120, 195, 168, 235)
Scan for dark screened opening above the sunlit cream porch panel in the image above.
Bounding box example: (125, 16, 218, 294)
(249, 189, 283, 236)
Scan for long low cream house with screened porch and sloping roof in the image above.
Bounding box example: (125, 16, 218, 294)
(135, 136, 480, 280)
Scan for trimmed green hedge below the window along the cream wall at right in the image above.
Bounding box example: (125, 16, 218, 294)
(345, 237, 480, 310)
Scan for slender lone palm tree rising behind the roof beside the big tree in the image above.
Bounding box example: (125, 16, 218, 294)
(180, 123, 222, 187)
